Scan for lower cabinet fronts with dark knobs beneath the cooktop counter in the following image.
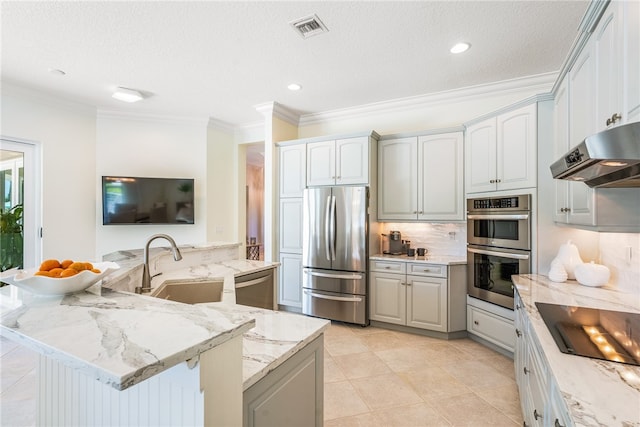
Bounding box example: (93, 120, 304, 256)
(514, 292, 573, 427)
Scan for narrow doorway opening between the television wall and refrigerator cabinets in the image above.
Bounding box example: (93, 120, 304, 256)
(246, 143, 264, 260)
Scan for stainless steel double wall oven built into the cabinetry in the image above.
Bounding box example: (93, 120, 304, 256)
(467, 194, 531, 310)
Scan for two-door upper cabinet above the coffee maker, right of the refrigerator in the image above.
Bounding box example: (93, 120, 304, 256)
(378, 132, 464, 221)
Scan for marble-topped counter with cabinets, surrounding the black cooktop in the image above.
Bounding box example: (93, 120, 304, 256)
(512, 274, 640, 426)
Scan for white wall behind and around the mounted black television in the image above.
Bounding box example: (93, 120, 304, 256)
(91, 111, 208, 256)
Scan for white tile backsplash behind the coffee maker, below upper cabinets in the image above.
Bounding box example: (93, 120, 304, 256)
(380, 223, 467, 256)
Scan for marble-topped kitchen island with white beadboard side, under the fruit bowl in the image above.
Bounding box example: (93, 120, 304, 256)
(0, 246, 328, 425)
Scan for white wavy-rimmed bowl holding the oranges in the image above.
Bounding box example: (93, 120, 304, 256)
(0, 262, 120, 295)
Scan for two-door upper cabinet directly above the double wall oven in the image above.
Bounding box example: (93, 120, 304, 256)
(465, 103, 538, 193)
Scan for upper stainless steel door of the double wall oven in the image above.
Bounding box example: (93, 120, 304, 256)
(467, 212, 531, 250)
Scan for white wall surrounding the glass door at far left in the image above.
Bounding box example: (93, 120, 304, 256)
(0, 82, 97, 260)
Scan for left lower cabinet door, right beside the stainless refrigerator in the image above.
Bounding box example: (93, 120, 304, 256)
(369, 273, 406, 325)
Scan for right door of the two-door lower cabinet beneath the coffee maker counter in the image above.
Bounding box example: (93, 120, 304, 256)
(407, 276, 447, 332)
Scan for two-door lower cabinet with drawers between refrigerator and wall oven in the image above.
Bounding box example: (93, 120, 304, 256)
(369, 261, 466, 333)
